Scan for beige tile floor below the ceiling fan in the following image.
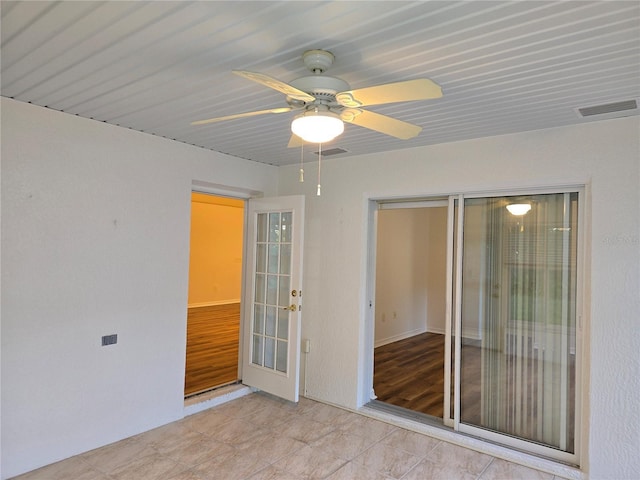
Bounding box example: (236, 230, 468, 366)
(16, 393, 559, 480)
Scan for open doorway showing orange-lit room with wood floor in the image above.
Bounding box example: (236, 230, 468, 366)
(184, 192, 245, 397)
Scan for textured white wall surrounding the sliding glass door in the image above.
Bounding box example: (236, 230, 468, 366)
(280, 117, 640, 479)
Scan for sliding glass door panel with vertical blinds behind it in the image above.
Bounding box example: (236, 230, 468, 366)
(452, 192, 578, 461)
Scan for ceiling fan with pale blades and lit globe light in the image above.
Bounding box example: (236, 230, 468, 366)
(191, 50, 442, 147)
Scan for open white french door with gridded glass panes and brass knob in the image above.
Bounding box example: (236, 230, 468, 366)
(242, 195, 304, 402)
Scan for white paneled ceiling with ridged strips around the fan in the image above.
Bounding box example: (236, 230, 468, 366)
(1, 0, 640, 165)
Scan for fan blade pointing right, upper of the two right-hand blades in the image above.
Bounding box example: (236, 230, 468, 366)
(336, 78, 442, 108)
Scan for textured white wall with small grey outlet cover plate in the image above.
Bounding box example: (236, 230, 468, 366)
(1, 98, 277, 478)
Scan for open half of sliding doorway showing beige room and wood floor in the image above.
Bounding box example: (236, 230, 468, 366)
(373, 200, 447, 423)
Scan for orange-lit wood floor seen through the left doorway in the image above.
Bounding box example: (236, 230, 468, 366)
(184, 303, 240, 396)
